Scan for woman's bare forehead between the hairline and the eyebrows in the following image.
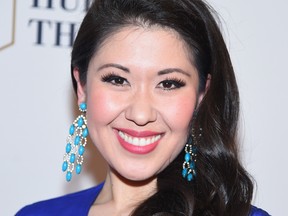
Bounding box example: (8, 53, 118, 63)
(91, 26, 194, 69)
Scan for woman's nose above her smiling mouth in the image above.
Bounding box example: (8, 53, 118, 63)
(125, 91, 157, 126)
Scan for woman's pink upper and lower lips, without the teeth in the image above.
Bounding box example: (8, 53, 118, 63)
(115, 128, 162, 154)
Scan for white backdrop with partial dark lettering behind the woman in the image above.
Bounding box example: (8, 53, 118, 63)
(0, 0, 288, 215)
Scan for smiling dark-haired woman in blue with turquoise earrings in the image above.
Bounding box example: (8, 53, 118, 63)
(18, 0, 268, 216)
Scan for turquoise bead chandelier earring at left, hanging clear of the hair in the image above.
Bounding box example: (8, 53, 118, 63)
(62, 103, 88, 182)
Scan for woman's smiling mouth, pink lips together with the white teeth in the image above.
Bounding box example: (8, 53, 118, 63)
(116, 129, 163, 154)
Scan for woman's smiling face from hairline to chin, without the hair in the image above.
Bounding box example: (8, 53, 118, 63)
(74, 27, 201, 180)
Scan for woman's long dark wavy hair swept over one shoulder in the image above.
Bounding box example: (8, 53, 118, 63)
(71, 0, 253, 216)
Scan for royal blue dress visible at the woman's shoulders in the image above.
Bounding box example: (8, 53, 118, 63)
(16, 183, 269, 216)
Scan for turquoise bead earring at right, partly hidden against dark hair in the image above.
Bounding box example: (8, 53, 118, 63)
(182, 128, 202, 181)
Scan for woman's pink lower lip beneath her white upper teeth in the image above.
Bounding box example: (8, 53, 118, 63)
(116, 131, 161, 154)
